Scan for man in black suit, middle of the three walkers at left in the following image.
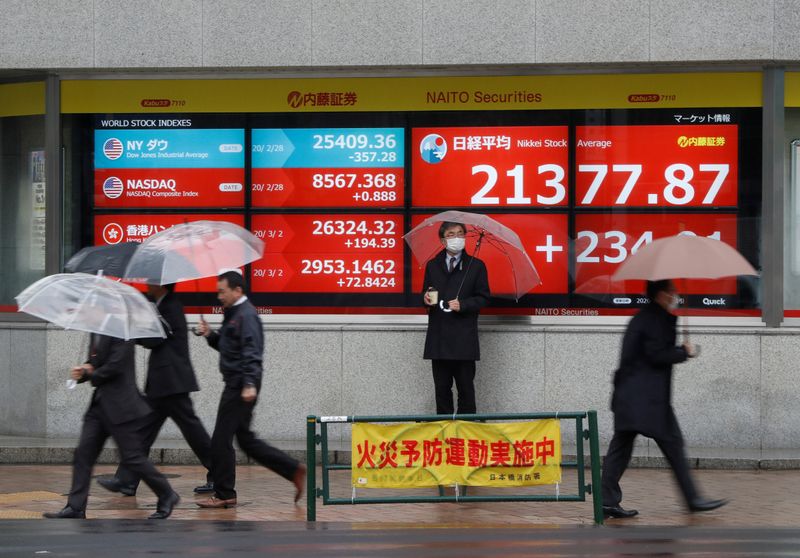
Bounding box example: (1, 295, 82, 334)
(97, 285, 214, 496)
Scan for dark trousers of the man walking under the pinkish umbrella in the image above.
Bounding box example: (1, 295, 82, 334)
(602, 413, 697, 506)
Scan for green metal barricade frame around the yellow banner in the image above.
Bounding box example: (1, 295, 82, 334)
(306, 411, 603, 525)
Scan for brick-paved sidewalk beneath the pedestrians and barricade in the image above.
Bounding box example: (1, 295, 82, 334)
(0, 465, 800, 528)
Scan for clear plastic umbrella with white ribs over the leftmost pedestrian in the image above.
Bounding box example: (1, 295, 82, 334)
(16, 273, 166, 340)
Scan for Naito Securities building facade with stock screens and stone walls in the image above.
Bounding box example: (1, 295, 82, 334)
(0, 0, 800, 458)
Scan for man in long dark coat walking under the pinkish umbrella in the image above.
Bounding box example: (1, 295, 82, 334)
(602, 280, 726, 518)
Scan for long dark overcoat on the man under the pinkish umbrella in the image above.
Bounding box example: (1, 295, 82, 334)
(611, 303, 688, 438)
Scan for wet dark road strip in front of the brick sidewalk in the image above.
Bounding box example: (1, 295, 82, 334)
(0, 520, 800, 558)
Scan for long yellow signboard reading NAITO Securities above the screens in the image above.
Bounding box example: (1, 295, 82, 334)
(61, 72, 762, 114)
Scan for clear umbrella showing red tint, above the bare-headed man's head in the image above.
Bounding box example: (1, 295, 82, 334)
(123, 221, 264, 285)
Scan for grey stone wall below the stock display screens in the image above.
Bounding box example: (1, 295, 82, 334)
(0, 323, 800, 456)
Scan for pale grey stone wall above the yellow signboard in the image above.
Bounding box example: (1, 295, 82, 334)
(0, 0, 800, 69)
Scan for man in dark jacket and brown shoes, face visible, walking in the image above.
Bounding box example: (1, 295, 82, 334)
(197, 271, 306, 508)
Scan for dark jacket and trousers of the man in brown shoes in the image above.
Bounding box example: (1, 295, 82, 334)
(207, 300, 300, 500)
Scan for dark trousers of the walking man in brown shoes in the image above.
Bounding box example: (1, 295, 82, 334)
(211, 386, 299, 500)
